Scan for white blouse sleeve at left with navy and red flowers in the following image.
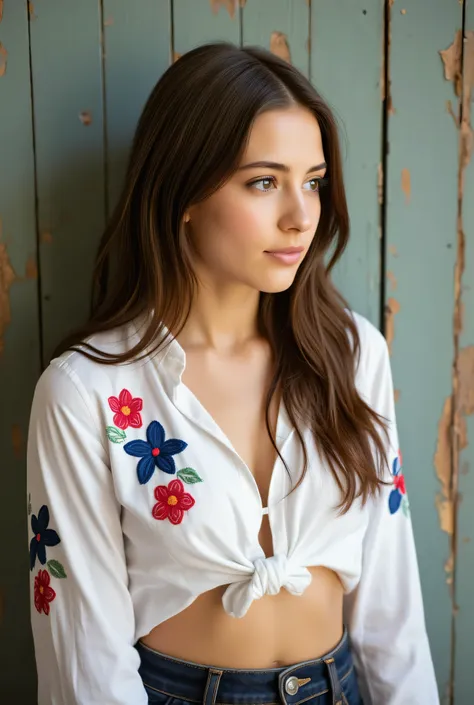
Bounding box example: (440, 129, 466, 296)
(28, 361, 148, 705)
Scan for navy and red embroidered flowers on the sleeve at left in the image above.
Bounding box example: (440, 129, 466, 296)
(28, 504, 67, 615)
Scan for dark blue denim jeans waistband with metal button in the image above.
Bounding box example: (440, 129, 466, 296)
(135, 631, 362, 705)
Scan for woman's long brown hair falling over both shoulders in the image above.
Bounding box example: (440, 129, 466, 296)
(54, 43, 386, 512)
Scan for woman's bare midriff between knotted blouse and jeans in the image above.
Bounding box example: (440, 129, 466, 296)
(141, 567, 343, 668)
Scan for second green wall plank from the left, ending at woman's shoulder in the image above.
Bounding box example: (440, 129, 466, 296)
(31, 0, 105, 361)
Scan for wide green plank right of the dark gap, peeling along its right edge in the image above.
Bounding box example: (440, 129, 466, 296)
(386, 0, 462, 702)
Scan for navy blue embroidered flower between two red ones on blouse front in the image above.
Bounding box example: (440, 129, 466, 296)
(123, 421, 188, 485)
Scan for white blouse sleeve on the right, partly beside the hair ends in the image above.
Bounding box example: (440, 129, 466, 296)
(345, 332, 439, 705)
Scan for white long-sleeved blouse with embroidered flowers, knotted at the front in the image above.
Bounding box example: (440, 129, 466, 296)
(28, 314, 439, 705)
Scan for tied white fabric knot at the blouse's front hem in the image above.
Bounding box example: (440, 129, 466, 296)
(222, 553, 312, 617)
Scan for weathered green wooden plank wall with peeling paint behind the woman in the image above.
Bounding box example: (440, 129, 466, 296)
(0, 0, 474, 705)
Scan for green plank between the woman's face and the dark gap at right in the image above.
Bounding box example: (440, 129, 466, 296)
(311, 0, 383, 326)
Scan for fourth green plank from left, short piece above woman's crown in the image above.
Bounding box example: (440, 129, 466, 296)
(173, 0, 240, 58)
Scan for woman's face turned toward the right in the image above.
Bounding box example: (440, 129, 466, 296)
(185, 107, 326, 293)
